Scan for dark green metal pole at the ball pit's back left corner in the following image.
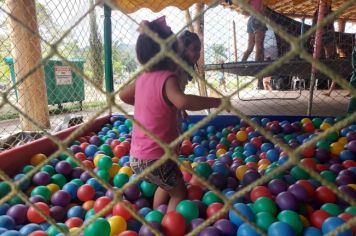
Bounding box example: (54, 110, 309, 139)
(104, 4, 114, 93)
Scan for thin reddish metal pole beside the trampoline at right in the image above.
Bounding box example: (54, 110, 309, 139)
(307, 0, 326, 116)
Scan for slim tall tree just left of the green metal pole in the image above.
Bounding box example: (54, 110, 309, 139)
(89, 0, 104, 86)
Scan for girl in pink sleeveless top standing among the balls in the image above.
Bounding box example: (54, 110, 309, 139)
(120, 17, 221, 211)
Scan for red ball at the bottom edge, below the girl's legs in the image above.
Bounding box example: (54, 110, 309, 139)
(161, 211, 187, 236)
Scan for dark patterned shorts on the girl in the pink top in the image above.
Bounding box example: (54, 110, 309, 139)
(130, 157, 183, 191)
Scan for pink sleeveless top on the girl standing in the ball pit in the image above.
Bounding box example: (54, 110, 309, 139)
(130, 71, 179, 160)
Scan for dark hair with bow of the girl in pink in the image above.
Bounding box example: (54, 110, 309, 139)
(136, 21, 177, 71)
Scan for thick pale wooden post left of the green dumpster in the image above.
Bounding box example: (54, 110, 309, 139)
(6, 0, 50, 131)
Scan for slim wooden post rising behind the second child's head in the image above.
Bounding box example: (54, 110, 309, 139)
(195, 3, 207, 96)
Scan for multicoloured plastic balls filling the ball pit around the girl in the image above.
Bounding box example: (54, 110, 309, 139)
(0, 116, 356, 236)
